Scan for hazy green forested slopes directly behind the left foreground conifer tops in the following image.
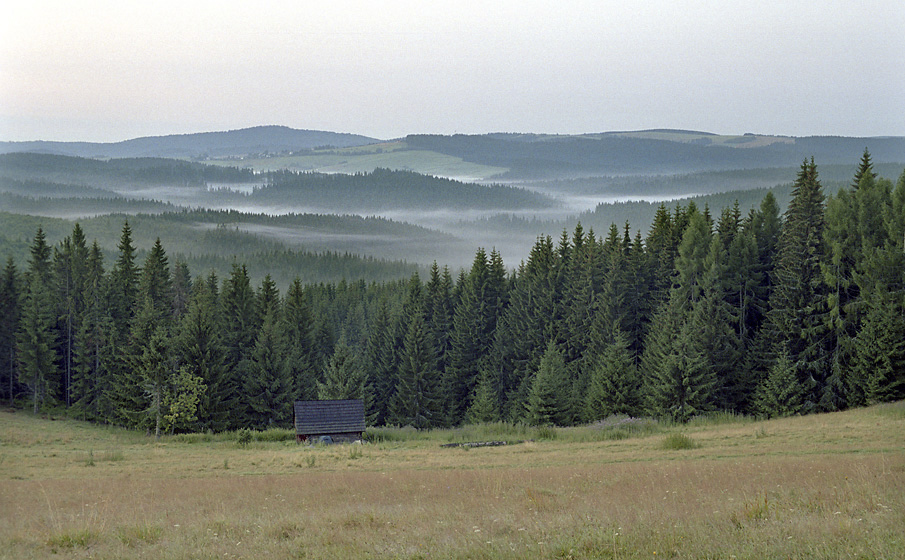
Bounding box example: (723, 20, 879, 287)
(0, 210, 424, 288)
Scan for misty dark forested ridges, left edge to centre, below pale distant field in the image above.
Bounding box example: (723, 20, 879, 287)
(0, 153, 556, 215)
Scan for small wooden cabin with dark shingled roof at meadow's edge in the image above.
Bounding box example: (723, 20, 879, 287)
(295, 399, 365, 443)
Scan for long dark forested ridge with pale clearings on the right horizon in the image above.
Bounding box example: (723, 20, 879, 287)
(405, 131, 905, 179)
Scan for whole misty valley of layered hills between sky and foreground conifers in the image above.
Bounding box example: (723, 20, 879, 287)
(0, 127, 905, 280)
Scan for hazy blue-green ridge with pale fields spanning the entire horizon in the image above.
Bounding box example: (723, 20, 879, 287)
(0, 126, 905, 181)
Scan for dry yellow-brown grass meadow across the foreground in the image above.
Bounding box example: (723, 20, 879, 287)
(0, 402, 905, 559)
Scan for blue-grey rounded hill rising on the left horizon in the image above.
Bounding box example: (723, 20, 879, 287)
(0, 126, 379, 158)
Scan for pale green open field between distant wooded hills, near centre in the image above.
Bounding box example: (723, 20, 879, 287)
(207, 142, 508, 181)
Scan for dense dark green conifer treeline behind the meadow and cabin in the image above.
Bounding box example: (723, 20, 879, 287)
(0, 155, 905, 433)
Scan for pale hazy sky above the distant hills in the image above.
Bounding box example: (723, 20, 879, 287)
(0, 0, 905, 142)
